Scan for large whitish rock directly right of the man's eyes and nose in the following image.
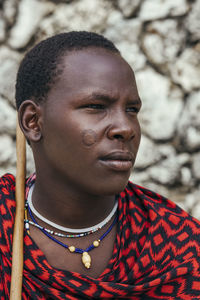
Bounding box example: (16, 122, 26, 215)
(136, 68, 183, 141)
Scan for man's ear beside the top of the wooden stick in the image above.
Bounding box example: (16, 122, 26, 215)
(18, 100, 42, 143)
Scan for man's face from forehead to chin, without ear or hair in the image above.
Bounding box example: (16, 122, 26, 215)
(37, 48, 141, 195)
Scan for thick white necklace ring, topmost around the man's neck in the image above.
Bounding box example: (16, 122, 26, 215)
(27, 184, 118, 233)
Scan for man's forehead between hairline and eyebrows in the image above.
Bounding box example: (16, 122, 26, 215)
(48, 48, 137, 99)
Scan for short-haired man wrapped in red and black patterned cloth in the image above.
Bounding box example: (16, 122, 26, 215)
(0, 32, 200, 299)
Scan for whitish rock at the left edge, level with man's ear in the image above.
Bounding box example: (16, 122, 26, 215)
(0, 97, 16, 135)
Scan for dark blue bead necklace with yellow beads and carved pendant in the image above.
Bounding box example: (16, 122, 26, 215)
(25, 201, 118, 269)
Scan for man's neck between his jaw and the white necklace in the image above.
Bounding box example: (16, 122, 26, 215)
(32, 174, 115, 228)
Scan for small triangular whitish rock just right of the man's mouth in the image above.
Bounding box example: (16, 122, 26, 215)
(135, 135, 161, 169)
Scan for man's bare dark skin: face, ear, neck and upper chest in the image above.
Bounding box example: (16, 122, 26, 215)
(19, 48, 141, 277)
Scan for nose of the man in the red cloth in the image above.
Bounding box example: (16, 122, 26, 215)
(107, 114, 136, 141)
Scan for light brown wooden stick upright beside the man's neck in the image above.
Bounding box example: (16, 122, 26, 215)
(10, 122, 26, 300)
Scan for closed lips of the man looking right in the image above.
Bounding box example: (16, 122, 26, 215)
(100, 151, 134, 172)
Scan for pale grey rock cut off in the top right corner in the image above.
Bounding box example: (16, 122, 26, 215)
(186, 0, 200, 41)
